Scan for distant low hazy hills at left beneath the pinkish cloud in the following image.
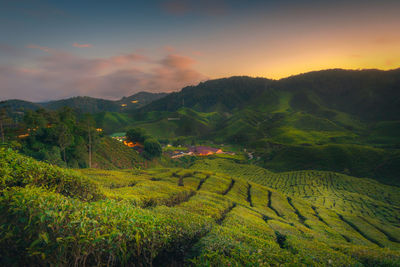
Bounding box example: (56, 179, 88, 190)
(0, 92, 167, 113)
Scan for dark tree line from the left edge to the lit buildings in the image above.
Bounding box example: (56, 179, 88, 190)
(0, 107, 102, 168)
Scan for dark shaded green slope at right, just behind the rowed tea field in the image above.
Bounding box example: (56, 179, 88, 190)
(262, 144, 400, 185)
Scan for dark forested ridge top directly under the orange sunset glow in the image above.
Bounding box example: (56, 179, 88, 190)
(141, 69, 400, 120)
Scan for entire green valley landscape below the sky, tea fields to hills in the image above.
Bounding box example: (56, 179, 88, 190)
(0, 70, 400, 266)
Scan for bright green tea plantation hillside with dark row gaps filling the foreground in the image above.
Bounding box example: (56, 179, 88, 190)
(0, 149, 400, 266)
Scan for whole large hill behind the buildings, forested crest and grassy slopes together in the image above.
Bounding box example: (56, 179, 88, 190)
(128, 69, 400, 186)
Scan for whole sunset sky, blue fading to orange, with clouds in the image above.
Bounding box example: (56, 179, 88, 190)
(0, 0, 400, 102)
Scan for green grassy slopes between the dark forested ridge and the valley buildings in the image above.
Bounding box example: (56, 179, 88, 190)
(126, 102, 400, 185)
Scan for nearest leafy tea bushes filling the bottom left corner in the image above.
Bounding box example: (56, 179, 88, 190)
(0, 188, 209, 265)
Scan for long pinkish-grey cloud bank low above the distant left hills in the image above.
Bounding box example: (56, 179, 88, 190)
(0, 45, 207, 101)
